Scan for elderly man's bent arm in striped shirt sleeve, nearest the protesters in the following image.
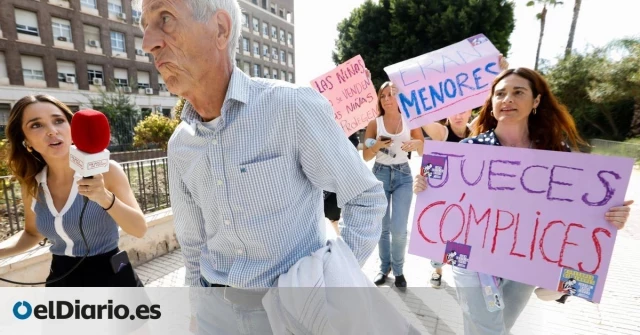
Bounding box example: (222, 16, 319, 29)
(295, 88, 387, 265)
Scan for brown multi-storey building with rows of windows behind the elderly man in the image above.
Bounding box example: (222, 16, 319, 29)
(0, 0, 295, 131)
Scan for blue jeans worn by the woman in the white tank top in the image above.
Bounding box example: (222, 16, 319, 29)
(373, 163, 413, 277)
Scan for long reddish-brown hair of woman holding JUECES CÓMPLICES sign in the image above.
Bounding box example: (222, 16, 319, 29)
(471, 67, 586, 151)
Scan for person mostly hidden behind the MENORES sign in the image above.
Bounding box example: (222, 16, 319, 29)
(422, 54, 509, 288)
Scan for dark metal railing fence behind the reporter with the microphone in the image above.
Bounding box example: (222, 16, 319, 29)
(0, 157, 171, 241)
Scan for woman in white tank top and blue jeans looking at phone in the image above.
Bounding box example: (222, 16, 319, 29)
(362, 82, 424, 289)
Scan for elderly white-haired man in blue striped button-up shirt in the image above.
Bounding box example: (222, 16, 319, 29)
(141, 0, 387, 334)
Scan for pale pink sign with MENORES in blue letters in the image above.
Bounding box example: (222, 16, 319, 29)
(384, 34, 500, 129)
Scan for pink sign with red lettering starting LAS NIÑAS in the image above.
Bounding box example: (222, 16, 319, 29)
(311, 55, 378, 136)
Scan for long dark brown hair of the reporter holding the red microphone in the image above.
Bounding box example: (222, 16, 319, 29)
(6, 94, 73, 197)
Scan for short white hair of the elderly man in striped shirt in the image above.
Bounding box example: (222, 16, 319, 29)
(132, 0, 242, 67)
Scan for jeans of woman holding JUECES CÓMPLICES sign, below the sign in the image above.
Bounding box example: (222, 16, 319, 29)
(451, 266, 535, 335)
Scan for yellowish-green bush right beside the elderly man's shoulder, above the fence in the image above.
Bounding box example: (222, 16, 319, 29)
(133, 114, 180, 151)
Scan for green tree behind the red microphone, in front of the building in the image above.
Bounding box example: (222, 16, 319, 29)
(87, 86, 142, 150)
